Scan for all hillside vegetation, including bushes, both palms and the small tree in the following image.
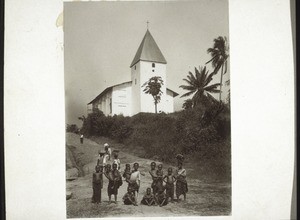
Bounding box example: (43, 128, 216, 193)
(68, 37, 231, 172)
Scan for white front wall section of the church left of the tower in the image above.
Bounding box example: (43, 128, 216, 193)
(112, 83, 131, 116)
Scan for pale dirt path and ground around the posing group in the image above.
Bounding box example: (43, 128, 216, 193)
(66, 134, 231, 218)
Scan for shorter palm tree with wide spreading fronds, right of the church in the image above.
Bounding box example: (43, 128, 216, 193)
(179, 67, 220, 107)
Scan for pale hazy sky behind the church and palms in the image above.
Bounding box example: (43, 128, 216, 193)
(63, 0, 230, 125)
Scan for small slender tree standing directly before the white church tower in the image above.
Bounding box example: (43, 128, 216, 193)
(142, 76, 163, 113)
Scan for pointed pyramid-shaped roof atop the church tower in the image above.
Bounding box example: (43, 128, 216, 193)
(130, 30, 167, 67)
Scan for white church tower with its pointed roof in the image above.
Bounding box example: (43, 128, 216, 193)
(130, 29, 167, 115)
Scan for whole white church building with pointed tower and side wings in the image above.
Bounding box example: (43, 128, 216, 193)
(88, 30, 178, 116)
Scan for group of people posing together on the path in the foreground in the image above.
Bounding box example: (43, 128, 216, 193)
(92, 143, 188, 206)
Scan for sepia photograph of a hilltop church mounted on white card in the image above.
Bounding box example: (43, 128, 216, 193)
(63, 0, 232, 218)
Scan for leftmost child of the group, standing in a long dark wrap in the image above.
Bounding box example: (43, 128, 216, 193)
(92, 164, 103, 204)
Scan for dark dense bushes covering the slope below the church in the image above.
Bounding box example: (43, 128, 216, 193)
(82, 103, 230, 162)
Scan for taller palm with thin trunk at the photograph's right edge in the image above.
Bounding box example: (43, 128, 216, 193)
(206, 36, 229, 101)
